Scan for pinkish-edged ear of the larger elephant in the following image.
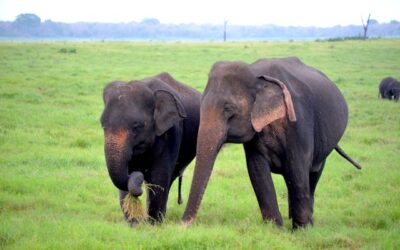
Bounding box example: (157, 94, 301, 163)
(251, 75, 296, 132)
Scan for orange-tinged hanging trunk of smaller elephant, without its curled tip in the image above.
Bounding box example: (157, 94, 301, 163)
(104, 130, 129, 191)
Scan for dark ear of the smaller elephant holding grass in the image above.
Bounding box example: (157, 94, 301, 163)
(154, 90, 186, 136)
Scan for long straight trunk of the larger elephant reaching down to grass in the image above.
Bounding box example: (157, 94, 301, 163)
(182, 112, 227, 225)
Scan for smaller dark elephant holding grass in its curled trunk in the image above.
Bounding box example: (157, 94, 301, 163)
(100, 73, 201, 224)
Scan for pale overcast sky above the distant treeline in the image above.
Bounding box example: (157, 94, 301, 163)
(0, 0, 400, 27)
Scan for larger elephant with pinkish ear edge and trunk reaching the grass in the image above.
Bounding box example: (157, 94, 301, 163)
(181, 57, 361, 229)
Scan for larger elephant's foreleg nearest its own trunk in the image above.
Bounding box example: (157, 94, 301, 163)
(244, 143, 283, 226)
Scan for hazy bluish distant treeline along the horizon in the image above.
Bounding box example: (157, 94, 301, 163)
(0, 14, 400, 40)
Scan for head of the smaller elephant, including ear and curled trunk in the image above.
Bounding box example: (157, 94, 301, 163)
(100, 79, 186, 196)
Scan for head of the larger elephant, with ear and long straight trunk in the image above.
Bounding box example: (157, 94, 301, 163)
(182, 62, 296, 224)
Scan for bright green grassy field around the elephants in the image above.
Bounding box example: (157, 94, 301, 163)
(0, 40, 400, 249)
